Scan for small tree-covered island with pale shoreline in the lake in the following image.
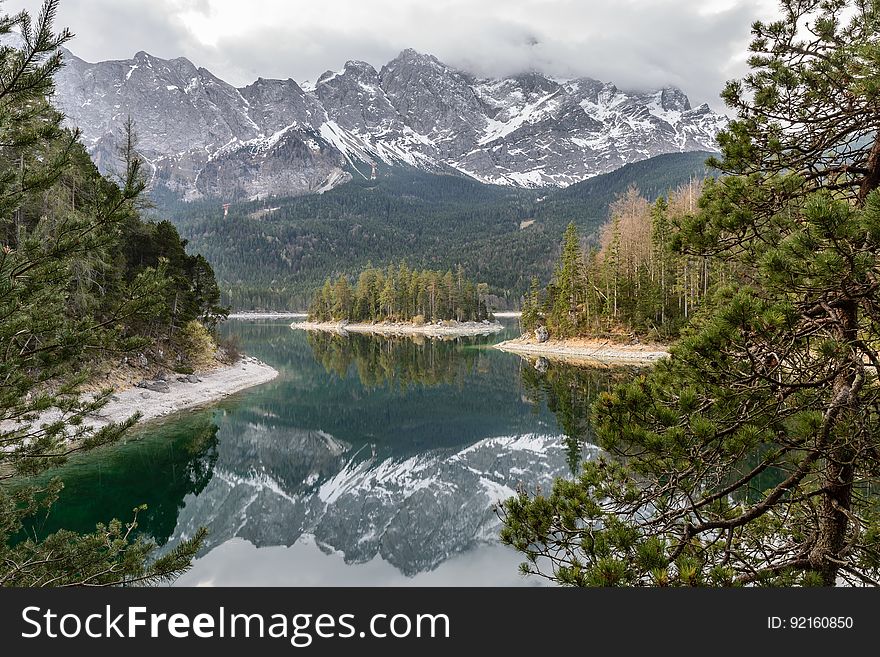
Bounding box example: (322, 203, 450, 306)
(291, 262, 502, 337)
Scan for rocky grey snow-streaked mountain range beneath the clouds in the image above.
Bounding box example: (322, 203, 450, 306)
(56, 50, 727, 199)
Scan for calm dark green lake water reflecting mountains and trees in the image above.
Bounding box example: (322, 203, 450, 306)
(27, 320, 626, 585)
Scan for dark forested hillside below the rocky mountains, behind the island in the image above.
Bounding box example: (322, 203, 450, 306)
(157, 153, 708, 310)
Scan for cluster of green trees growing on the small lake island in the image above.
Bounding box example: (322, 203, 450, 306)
(309, 262, 490, 324)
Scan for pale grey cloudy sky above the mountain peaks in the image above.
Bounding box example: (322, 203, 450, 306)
(2, 0, 776, 109)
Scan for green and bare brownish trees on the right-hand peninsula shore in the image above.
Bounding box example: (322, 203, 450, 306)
(522, 181, 728, 339)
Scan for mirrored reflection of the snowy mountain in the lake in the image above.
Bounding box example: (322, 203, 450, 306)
(165, 425, 596, 576)
